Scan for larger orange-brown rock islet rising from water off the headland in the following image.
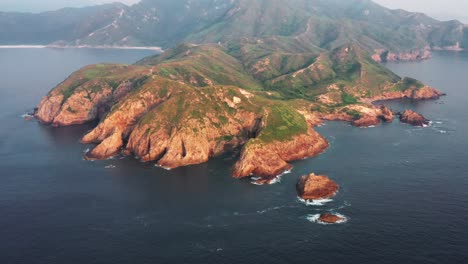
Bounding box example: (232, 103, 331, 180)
(296, 173, 339, 200)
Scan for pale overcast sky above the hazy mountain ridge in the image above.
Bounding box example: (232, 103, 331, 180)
(0, 0, 468, 23)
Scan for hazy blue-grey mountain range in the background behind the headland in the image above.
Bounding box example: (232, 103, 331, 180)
(0, 0, 468, 53)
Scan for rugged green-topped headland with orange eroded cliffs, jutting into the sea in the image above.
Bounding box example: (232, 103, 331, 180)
(35, 43, 439, 178)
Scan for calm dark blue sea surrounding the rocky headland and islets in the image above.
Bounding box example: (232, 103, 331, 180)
(0, 49, 468, 264)
